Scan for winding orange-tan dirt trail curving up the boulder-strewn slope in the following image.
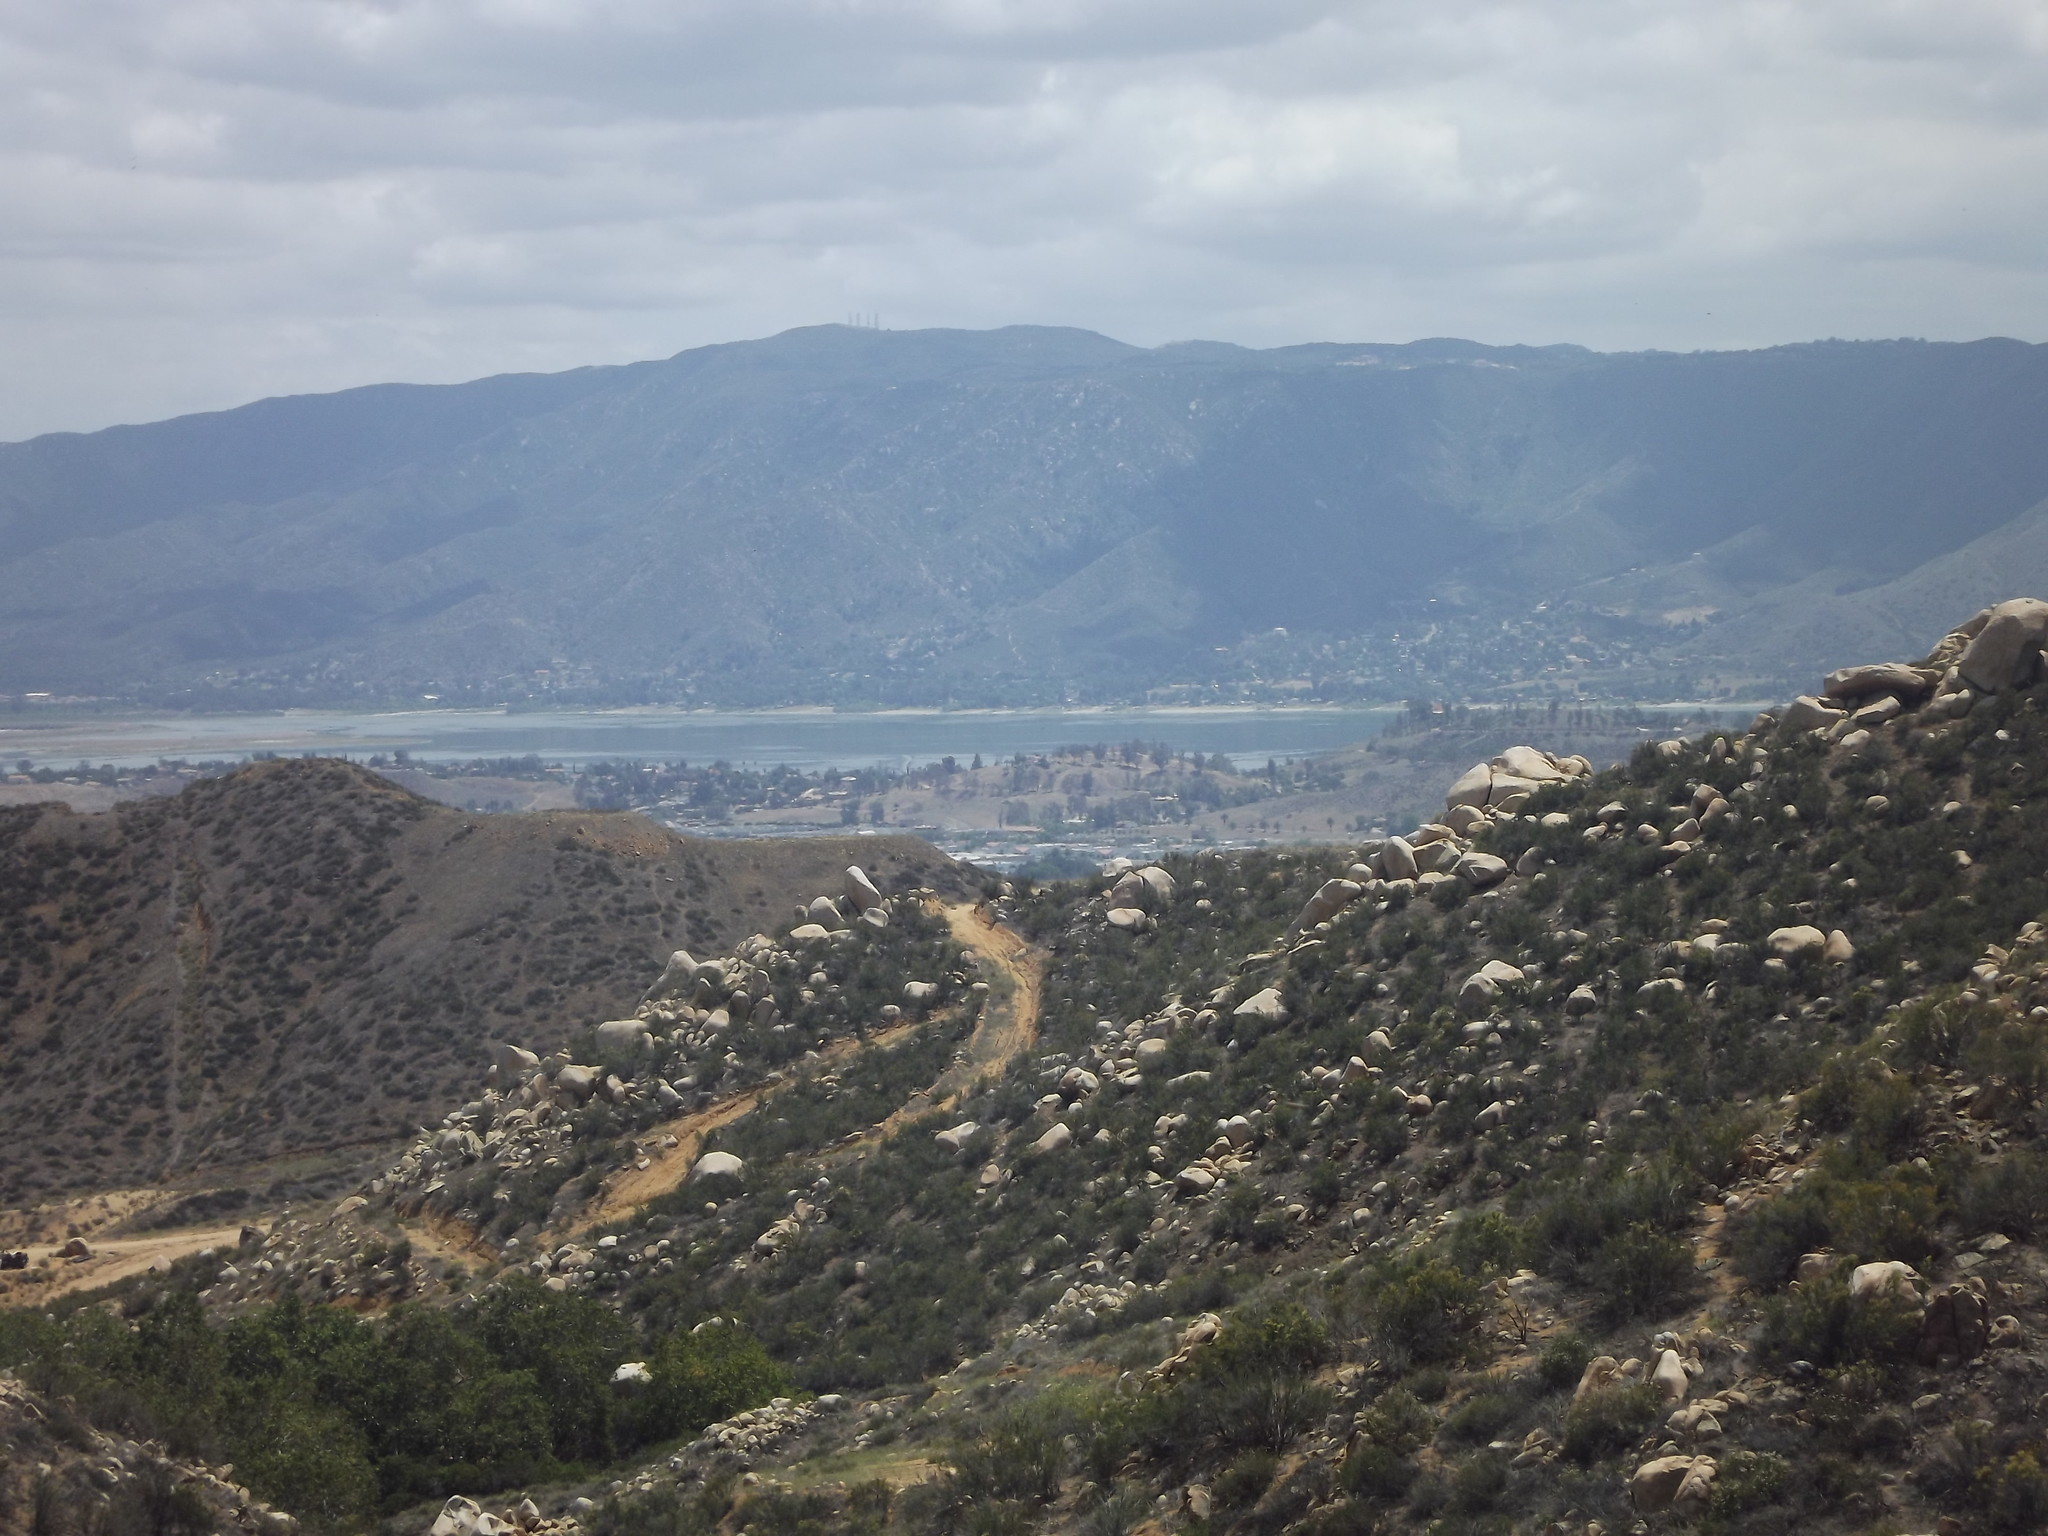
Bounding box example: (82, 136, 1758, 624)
(567, 901, 1044, 1235)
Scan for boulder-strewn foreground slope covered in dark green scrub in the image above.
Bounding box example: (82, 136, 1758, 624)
(19, 604, 2048, 1536)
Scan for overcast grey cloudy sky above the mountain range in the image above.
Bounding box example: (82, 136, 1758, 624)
(0, 0, 2048, 438)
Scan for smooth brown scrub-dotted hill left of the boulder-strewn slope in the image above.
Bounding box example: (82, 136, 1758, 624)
(0, 760, 967, 1204)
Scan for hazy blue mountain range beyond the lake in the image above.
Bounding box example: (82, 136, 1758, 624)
(0, 326, 2048, 705)
